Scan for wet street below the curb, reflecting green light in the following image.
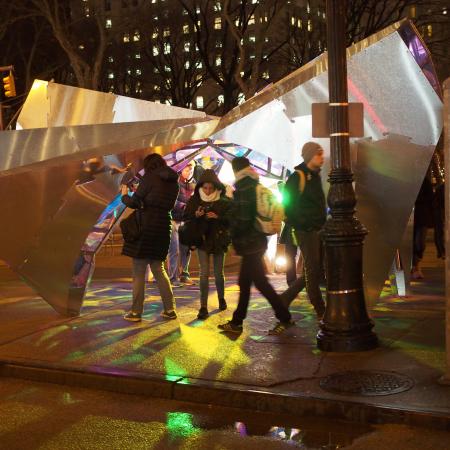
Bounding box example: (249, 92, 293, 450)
(0, 378, 372, 450)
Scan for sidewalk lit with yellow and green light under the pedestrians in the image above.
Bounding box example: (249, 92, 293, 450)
(0, 250, 450, 429)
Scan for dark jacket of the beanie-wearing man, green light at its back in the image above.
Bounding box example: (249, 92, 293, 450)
(283, 163, 327, 231)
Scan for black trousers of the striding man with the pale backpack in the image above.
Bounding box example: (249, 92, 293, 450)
(231, 252, 291, 325)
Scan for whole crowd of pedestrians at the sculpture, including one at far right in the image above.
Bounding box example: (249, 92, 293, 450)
(118, 142, 445, 334)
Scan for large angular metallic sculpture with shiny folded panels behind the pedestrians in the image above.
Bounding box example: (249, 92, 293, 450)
(0, 22, 442, 315)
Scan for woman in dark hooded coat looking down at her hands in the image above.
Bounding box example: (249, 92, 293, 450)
(184, 169, 231, 320)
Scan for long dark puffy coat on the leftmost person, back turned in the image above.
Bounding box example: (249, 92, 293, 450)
(122, 166, 178, 261)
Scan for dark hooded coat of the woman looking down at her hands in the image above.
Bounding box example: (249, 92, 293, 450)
(183, 170, 231, 254)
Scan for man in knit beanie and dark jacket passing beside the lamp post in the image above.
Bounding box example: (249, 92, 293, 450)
(283, 142, 326, 319)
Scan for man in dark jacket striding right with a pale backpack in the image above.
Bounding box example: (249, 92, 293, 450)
(219, 157, 293, 334)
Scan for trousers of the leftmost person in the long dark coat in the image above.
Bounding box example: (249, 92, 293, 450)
(131, 258, 175, 314)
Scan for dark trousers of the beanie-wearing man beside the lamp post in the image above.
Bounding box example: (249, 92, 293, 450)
(282, 231, 325, 317)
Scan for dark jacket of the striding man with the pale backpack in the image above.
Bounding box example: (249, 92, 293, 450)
(230, 169, 267, 256)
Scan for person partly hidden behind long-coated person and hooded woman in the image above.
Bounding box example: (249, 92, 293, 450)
(167, 161, 195, 287)
